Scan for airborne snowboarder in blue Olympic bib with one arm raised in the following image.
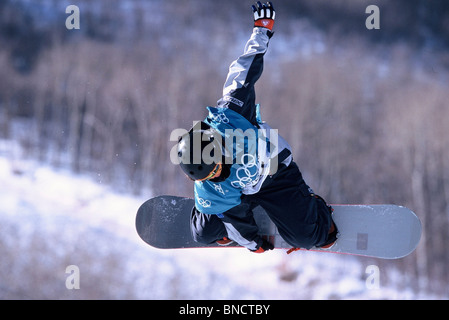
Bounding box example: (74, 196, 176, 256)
(177, 1, 338, 253)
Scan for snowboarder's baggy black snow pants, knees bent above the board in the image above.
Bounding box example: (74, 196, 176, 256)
(191, 161, 332, 249)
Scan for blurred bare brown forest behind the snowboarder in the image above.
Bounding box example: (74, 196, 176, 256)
(0, 0, 449, 292)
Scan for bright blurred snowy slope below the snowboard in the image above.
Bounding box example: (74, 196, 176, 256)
(0, 142, 441, 299)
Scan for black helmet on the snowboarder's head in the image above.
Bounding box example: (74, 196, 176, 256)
(178, 122, 222, 180)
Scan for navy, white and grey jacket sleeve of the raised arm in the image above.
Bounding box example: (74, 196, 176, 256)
(218, 27, 272, 124)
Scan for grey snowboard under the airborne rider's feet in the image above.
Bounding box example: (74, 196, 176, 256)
(136, 195, 421, 259)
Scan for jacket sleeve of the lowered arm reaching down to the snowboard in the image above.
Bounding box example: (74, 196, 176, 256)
(220, 202, 263, 251)
